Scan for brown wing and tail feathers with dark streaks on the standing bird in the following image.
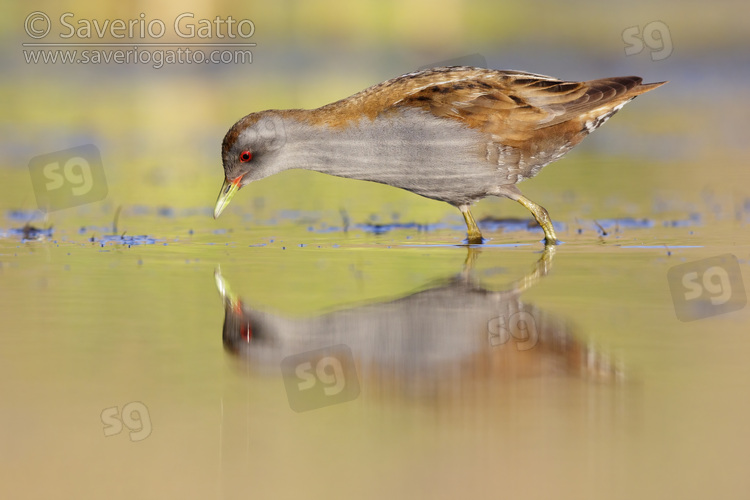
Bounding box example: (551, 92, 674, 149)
(381, 68, 661, 146)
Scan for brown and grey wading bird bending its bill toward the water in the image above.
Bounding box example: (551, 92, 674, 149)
(214, 66, 667, 245)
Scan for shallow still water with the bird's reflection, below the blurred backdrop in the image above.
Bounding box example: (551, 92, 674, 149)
(0, 202, 750, 498)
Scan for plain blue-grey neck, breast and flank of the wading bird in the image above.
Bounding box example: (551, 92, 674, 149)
(287, 109, 508, 205)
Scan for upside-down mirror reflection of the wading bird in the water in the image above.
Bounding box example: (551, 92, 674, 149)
(215, 246, 622, 396)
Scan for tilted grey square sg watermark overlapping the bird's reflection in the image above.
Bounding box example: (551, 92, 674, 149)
(281, 344, 359, 412)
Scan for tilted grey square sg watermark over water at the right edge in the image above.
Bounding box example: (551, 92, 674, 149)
(667, 254, 747, 321)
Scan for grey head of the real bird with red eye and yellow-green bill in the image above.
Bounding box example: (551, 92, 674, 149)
(214, 110, 286, 218)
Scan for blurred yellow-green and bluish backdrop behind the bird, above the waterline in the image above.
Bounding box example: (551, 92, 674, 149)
(0, 0, 750, 222)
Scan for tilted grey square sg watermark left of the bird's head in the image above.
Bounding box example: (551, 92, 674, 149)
(29, 144, 107, 211)
